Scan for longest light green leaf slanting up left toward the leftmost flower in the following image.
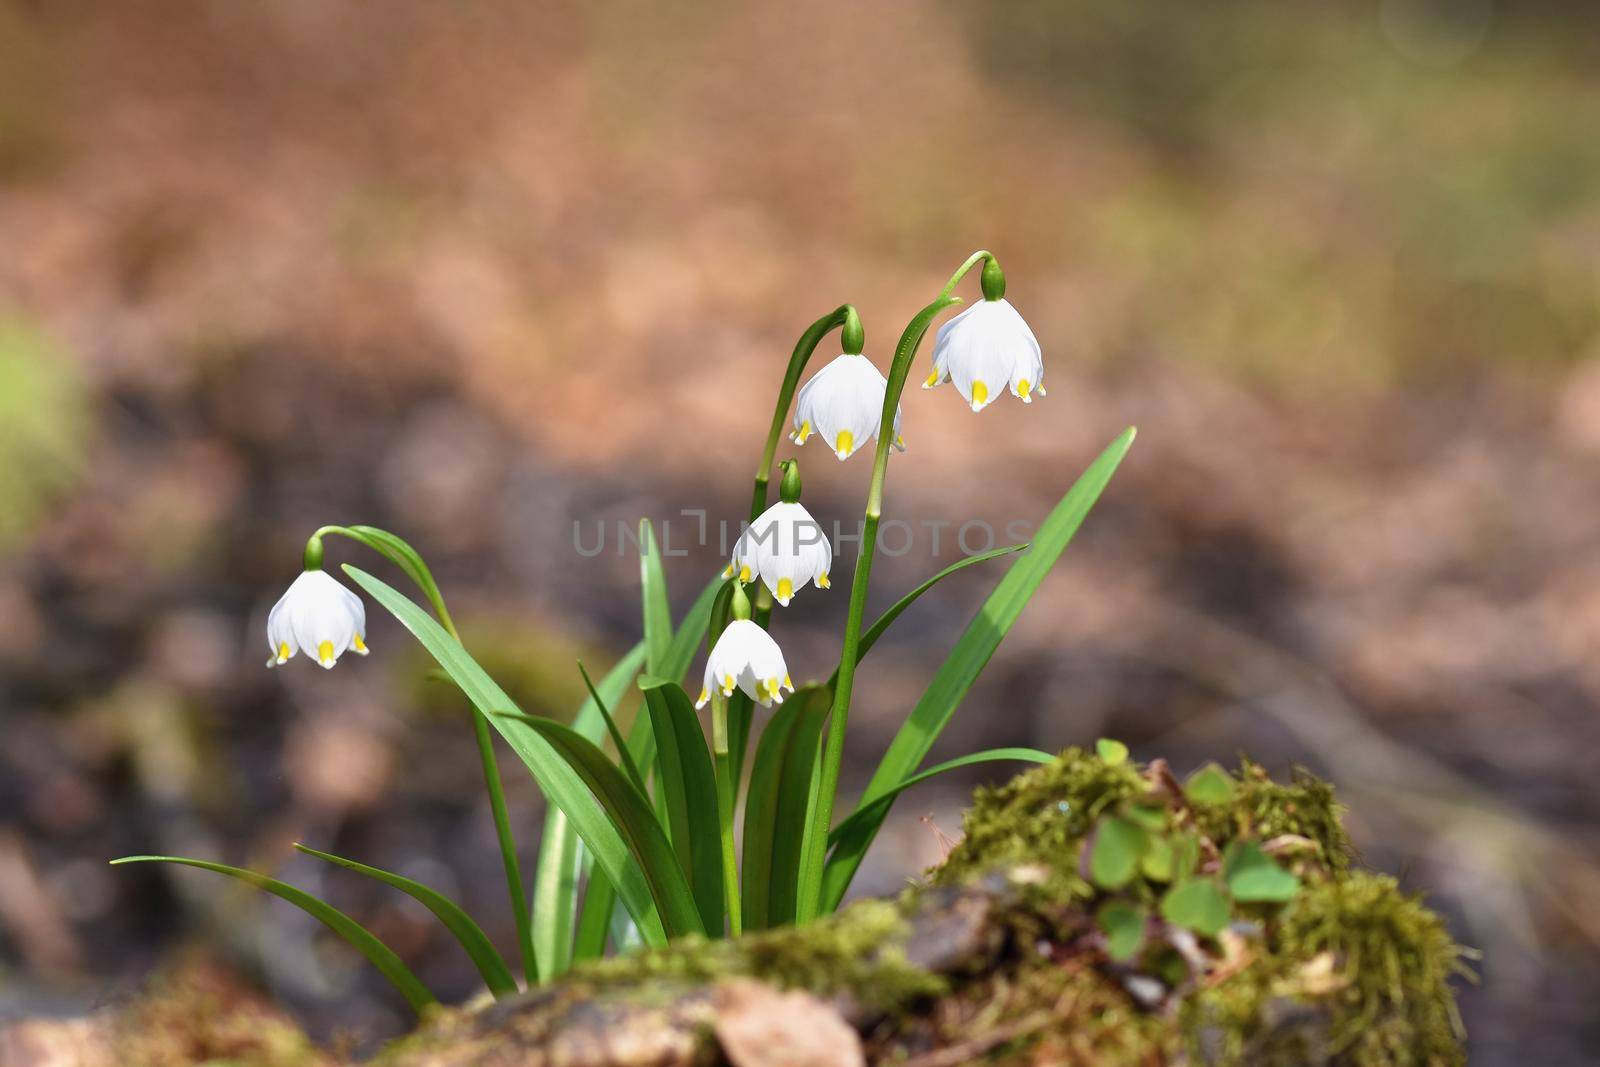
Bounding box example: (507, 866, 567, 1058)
(344, 565, 666, 945)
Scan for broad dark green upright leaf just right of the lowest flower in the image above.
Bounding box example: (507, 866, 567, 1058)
(741, 686, 834, 929)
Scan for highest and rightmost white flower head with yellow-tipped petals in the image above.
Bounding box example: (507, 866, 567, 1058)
(922, 259, 1045, 411)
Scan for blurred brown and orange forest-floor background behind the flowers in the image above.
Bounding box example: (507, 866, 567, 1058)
(0, 0, 1600, 1064)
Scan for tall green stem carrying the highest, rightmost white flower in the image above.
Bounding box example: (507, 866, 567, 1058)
(795, 265, 989, 923)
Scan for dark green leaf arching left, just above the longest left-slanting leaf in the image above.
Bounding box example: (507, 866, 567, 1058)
(498, 712, 706, 937)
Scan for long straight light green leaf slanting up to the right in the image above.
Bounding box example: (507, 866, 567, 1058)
(822, 427, 1134, 910)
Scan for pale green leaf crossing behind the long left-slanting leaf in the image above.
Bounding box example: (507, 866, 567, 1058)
(533, 641, 645, 981)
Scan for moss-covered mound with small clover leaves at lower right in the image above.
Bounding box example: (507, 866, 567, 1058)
(904, 749, 1464, 1067)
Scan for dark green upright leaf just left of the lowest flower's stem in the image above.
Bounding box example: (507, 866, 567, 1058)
(638, 678, 726, 936)
